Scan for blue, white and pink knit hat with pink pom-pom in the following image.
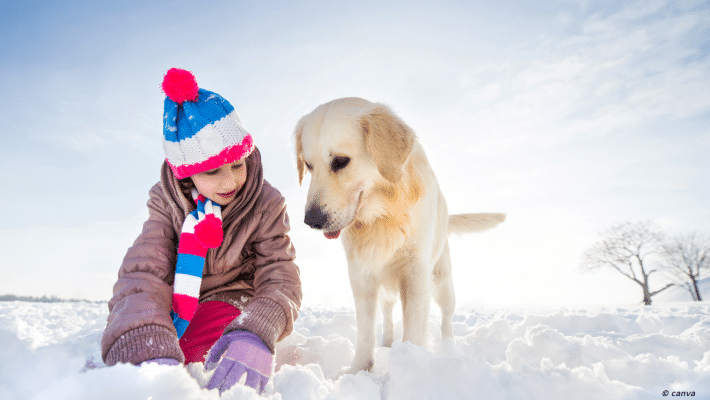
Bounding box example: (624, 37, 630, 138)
(162, 68, 254, 179)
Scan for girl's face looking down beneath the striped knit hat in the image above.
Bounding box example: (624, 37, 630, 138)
(190, 159, 247, 206)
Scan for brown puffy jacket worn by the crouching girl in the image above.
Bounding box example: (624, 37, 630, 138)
(101, 149, 301, 365)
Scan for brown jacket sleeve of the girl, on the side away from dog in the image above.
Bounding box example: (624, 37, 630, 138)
(101, 185, 184, 365)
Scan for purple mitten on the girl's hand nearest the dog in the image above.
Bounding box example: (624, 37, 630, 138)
(205, 331, 274, 394)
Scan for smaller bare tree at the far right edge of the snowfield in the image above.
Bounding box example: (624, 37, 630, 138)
(663, 233, 710, 301)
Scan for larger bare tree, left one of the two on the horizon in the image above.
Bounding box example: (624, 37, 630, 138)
(581, 221, 674, 305)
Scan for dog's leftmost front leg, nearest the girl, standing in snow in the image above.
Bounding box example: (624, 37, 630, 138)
(349, 267, 378, 374)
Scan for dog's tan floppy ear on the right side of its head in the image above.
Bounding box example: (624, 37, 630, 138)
(360, 104, 415, 182)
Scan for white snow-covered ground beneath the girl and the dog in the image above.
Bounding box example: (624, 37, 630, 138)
(0, 301, 710, 400)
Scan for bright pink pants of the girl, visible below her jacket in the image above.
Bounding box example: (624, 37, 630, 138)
(180, 301, 240, 365)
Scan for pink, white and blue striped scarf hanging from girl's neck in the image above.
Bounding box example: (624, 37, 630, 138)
(170, 188, 224, 339)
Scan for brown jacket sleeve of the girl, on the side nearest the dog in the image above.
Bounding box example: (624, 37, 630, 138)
(224, 195, 302, 353)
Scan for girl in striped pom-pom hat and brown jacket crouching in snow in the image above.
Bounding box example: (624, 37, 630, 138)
(101, 68, 301, 393)
